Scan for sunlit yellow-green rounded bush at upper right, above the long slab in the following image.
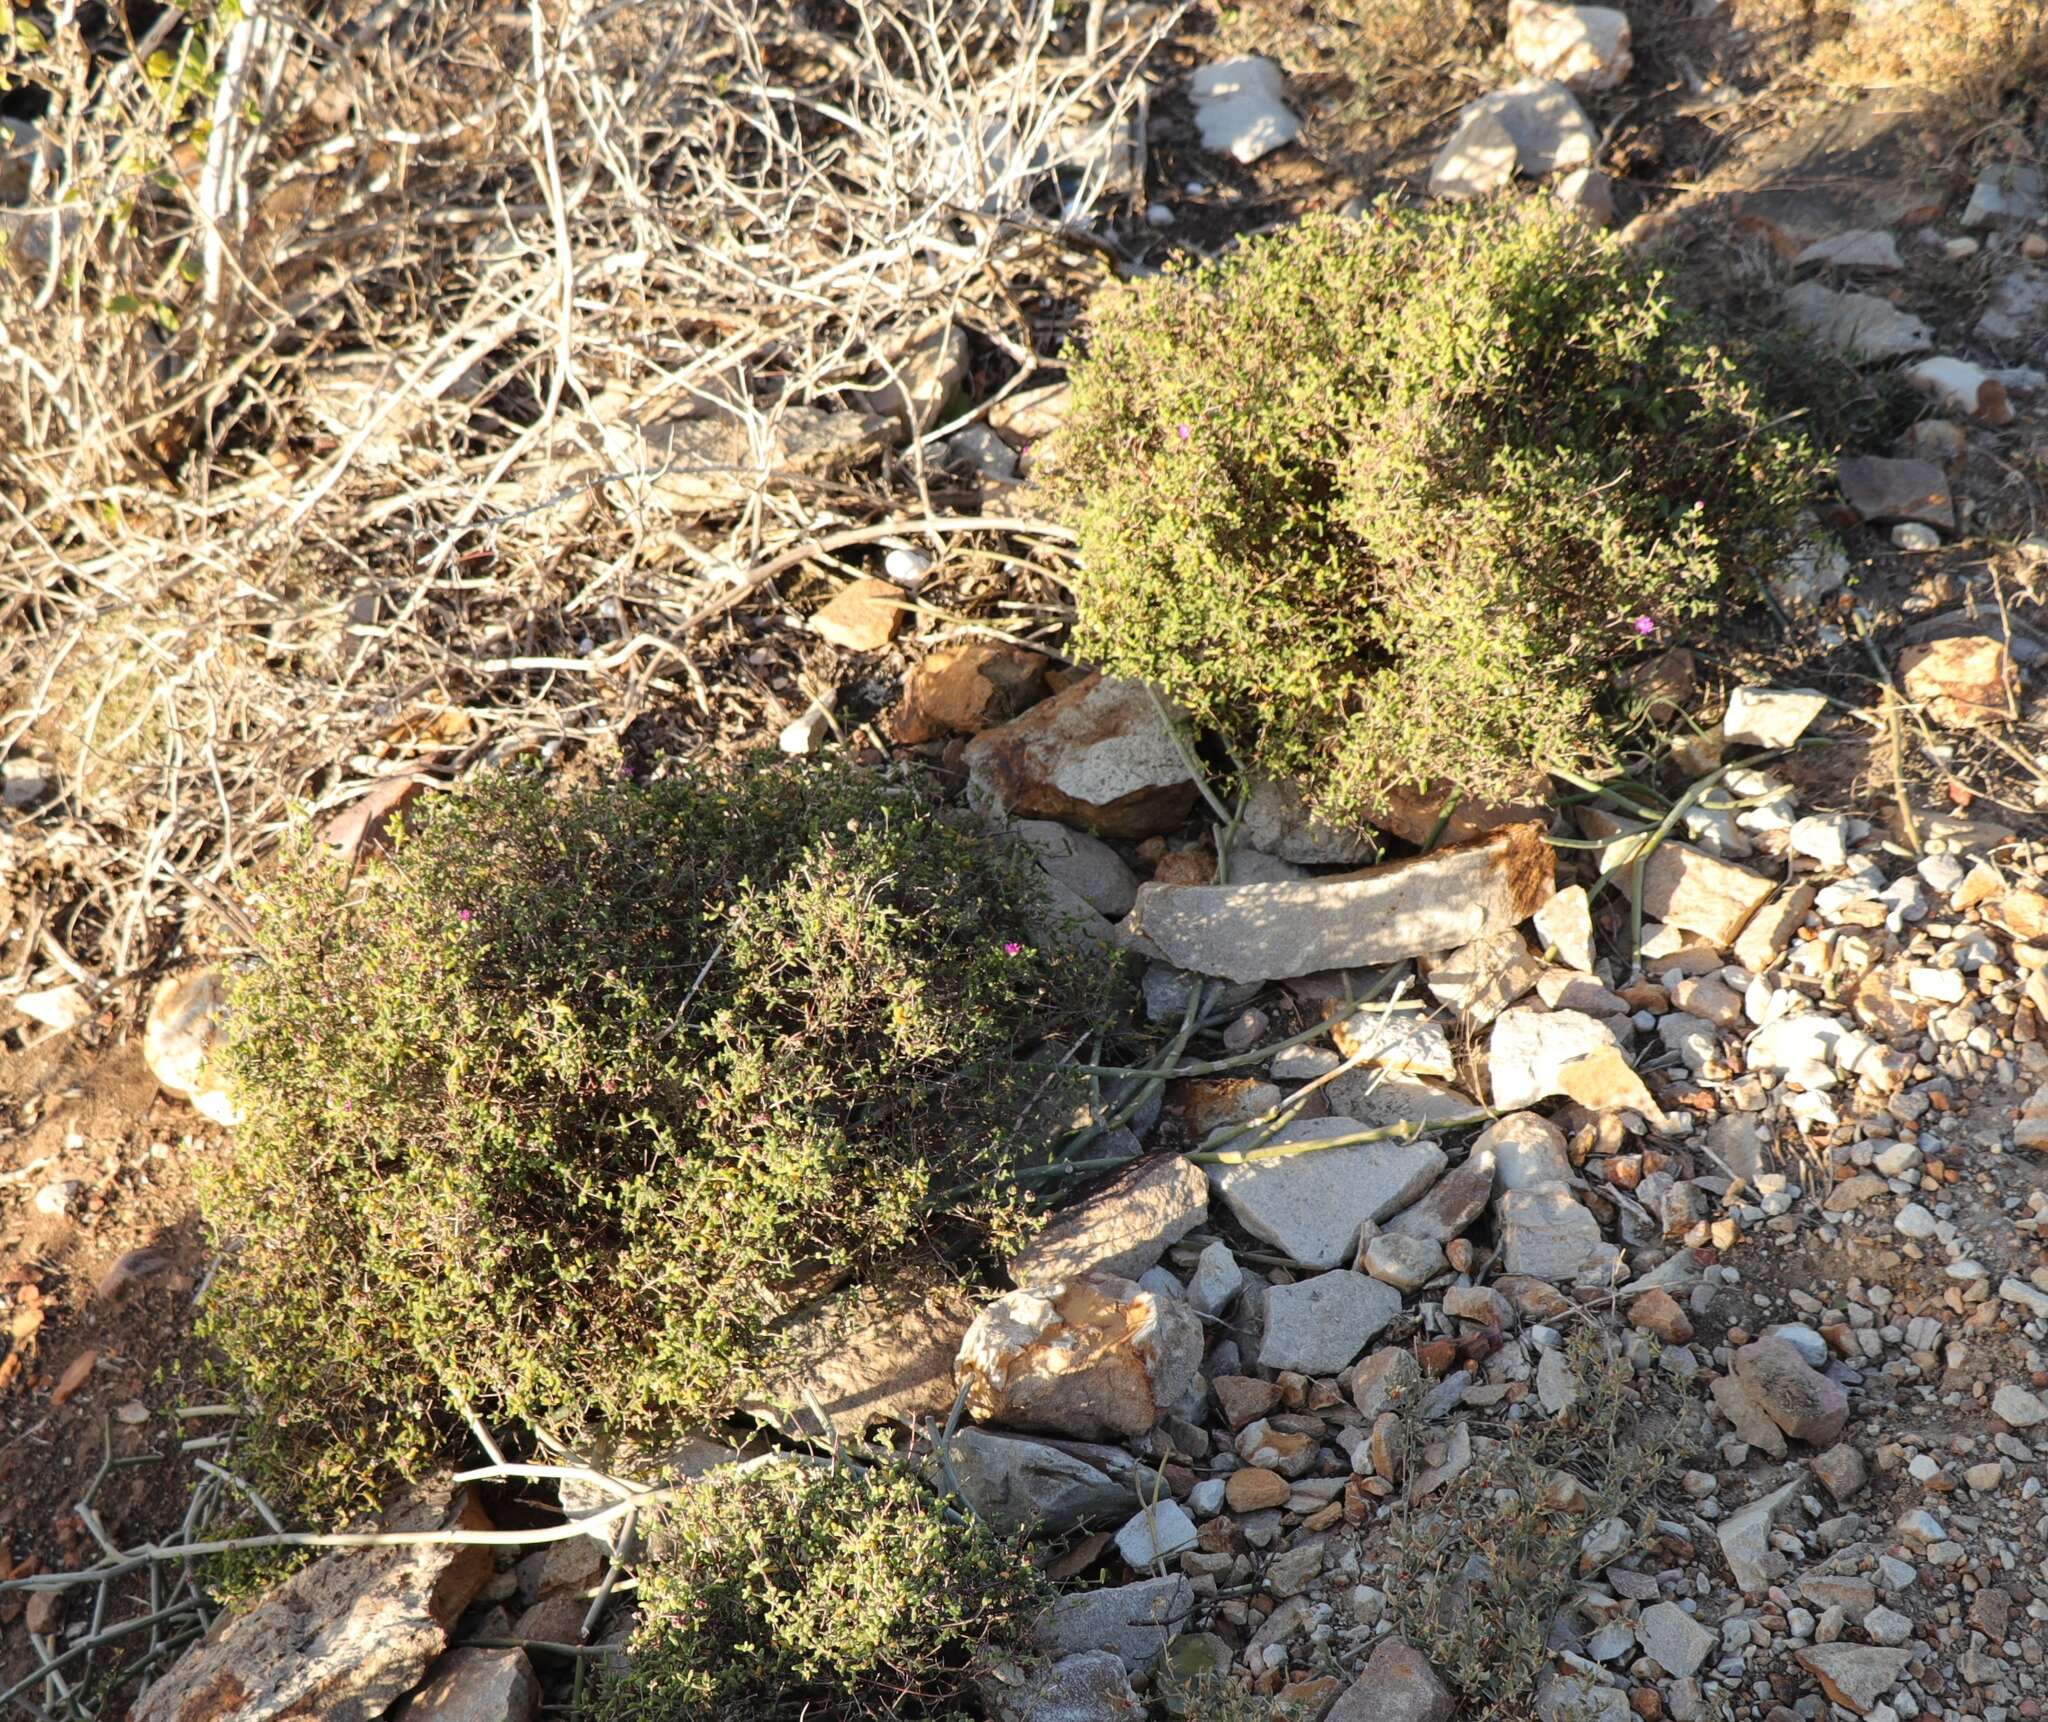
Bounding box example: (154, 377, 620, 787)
(1053, 205, 1815, 819)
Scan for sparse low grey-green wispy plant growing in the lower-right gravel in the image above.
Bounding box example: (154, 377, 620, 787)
(1384, 1331, 1683, 1722)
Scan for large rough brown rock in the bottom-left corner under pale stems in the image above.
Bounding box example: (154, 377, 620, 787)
(129, 1493, 492, 1722)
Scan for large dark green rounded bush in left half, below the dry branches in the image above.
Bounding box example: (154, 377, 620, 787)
(203, 764, 1116, 1513)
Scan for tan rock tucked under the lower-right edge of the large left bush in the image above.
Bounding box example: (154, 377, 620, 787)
(745, 1267, 975, 1439)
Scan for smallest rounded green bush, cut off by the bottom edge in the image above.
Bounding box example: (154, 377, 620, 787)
(596, 1466, 1049, 1722)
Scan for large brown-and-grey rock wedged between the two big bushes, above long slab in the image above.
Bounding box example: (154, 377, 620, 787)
(965, 676, 1196, 840)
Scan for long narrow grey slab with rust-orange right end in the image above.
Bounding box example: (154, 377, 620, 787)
(1126, 823, 1554, 981)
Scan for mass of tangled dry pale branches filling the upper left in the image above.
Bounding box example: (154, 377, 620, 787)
(0, 0, 1178, 991)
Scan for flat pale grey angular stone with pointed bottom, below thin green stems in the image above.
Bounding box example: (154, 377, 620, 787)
(1208, 1118, 1444, 1267)
